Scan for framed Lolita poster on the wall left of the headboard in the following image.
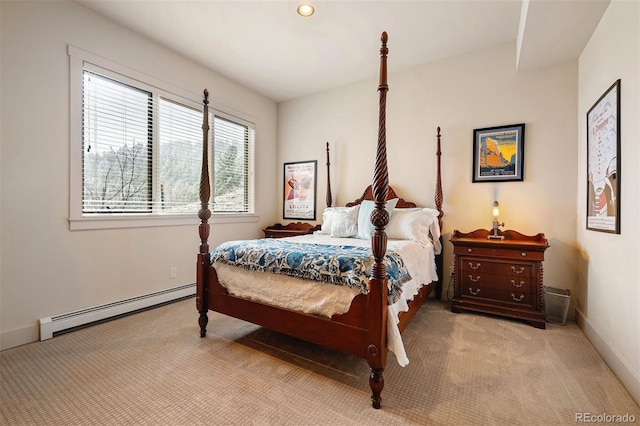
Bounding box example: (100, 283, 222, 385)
(282, 160, 317, 220)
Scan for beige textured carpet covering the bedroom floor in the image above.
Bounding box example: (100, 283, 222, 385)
(0, 299, 640, 425)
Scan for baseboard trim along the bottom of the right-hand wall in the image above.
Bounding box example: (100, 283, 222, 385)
(576, 308, 640, 404)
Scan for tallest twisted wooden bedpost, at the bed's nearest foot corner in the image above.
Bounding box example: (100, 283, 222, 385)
(367, 32, 389, 408)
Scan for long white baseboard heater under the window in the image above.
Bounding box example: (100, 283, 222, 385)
(38, 284, 196, 340)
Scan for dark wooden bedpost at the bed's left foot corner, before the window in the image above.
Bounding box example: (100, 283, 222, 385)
(196, 89, 211, 337)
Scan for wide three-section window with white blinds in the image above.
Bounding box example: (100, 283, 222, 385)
(69, 47, 255, 229)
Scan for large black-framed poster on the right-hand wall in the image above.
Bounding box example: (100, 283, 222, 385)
(587, 80, 620, 234)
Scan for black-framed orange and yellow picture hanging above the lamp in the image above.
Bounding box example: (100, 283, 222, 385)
(473, 123, 524, 182)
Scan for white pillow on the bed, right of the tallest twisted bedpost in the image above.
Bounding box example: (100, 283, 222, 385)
(385, 208, 440, 244)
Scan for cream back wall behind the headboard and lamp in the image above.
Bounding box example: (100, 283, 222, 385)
(278, 41, 578, 310)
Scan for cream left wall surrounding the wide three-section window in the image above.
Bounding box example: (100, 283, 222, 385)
(0, 1, 277, 348)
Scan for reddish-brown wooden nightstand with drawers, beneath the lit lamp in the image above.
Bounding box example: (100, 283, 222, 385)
(451, 229, 549, 328)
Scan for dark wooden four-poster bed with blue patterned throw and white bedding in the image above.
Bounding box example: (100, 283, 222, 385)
(196, 33, 442, 408)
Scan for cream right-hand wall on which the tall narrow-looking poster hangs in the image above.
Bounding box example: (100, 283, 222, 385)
(576, 0, 640, 401)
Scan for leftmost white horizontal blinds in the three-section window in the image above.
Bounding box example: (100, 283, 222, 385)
(82, 71, 153, 213)
